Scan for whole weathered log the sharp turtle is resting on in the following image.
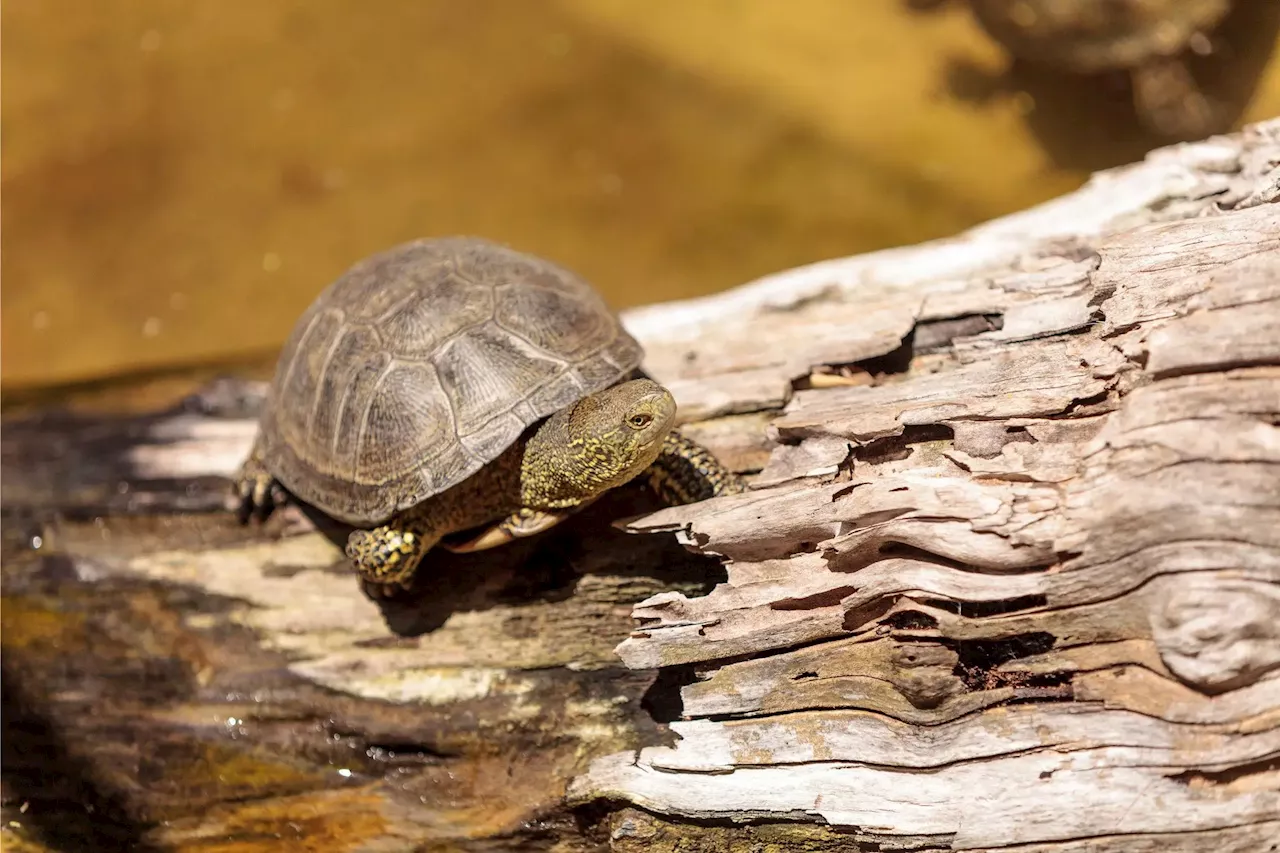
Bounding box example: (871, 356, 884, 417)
(3, 120, 1280, 853)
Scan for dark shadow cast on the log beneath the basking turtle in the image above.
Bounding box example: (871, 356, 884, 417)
(298, 484, 727, 638)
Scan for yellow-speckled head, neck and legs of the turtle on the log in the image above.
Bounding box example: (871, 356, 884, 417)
(237, 379, 746, 594)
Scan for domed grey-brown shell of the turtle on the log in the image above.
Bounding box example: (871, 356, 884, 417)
(260, 237, 643, 525)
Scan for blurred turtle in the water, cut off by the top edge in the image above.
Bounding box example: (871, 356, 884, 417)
(968, 0, 1231, 138)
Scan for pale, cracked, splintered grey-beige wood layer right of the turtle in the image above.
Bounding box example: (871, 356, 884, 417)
(572, 124, 1280, 850)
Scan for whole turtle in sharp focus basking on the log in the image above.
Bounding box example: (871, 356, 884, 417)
(233, 236, 746, 594)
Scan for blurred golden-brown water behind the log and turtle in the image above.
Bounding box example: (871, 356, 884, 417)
(0, 0, 1280, 403)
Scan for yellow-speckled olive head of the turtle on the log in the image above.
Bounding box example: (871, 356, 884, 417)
(521, 379, 676, 507)
